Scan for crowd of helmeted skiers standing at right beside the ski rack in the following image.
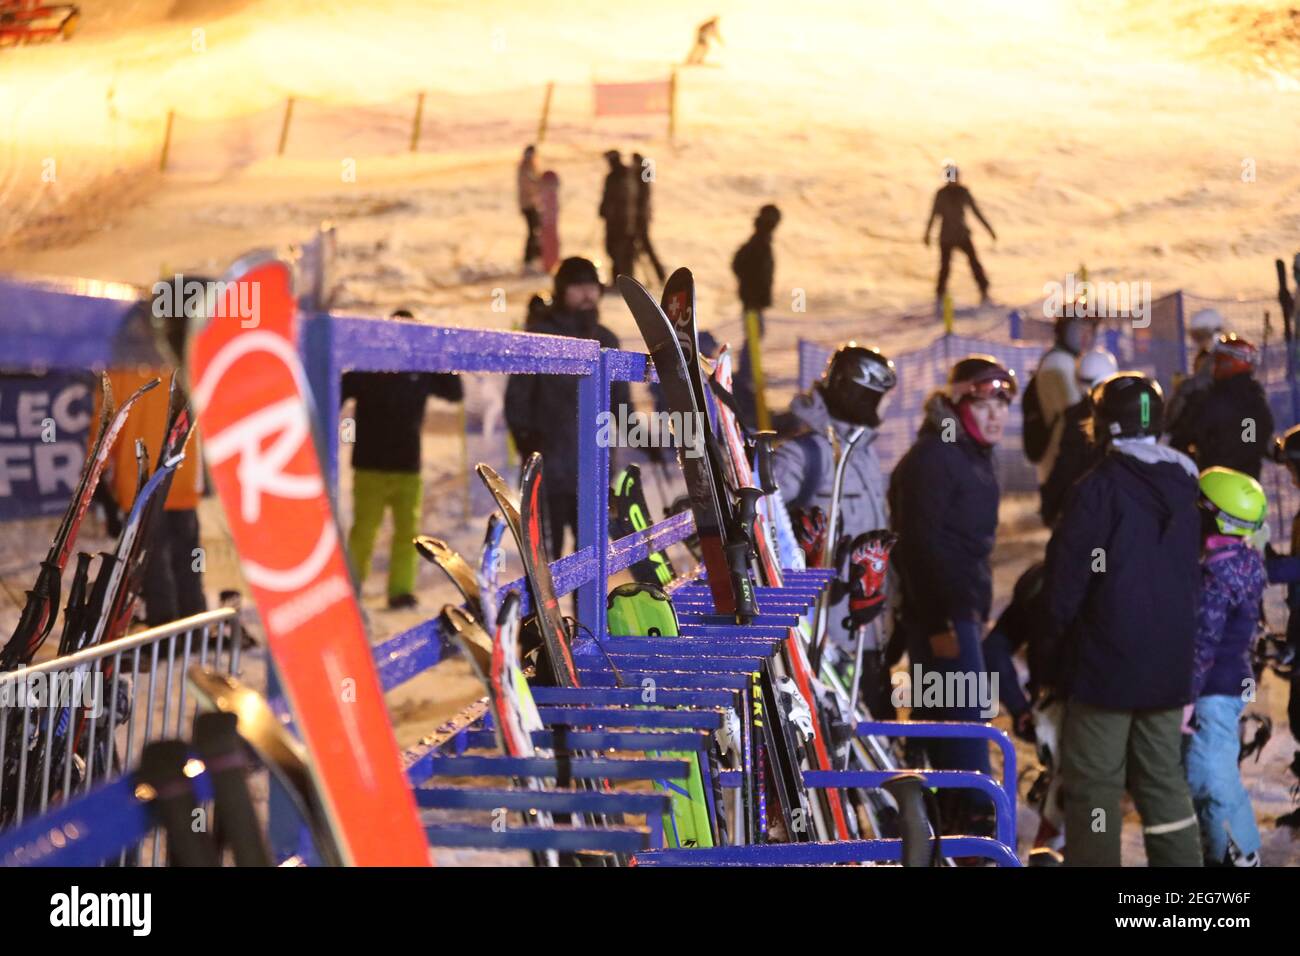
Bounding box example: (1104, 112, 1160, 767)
(776, 306, 1300, 866)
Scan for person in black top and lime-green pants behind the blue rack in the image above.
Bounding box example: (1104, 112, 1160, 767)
(343, 317, 464, 609)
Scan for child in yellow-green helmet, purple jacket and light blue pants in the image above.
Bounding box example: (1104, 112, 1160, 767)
(1184, 468, 1269, 866)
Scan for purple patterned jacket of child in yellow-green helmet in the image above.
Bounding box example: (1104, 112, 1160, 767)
(1192, 535, 1266, 697)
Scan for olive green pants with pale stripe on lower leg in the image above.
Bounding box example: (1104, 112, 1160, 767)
(1061, 697, 1201, 866)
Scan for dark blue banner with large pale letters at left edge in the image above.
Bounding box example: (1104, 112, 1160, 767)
(0, 372, 95, 522)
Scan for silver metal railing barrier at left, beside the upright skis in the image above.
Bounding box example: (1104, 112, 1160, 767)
(0, 607, 242, 864)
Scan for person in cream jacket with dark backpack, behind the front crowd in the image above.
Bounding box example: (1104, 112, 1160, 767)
(1024, 314, 1095, 489)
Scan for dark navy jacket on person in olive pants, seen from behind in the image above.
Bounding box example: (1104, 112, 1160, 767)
(1048, 440, 1201, 710)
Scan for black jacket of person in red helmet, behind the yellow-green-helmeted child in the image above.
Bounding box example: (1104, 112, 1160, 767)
(1169, 375, 1273, 479)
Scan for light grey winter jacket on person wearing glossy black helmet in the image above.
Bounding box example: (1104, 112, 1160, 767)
(772, 386, 889, 646)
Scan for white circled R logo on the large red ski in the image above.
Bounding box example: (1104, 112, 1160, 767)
(195, 332, 351, 630)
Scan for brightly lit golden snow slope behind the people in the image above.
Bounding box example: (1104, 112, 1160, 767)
(0, 0, 1300, 862)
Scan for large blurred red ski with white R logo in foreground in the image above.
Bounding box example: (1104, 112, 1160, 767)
(190, 254, 429, 866)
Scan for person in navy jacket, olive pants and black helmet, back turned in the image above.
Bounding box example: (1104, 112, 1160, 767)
(1047, 372, 1201, 866)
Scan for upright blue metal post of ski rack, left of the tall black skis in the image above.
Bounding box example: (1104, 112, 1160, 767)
(579, 349, 612, 640)
